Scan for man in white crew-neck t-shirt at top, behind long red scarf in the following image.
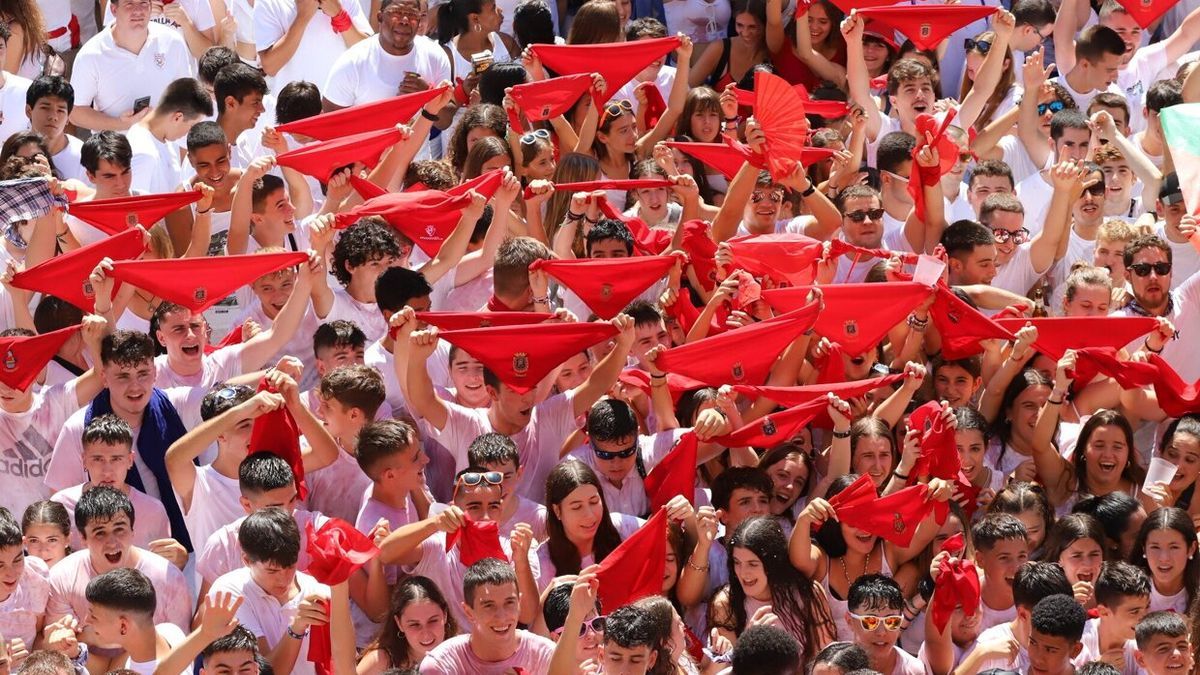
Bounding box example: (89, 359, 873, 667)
(320, 0, 454, 129)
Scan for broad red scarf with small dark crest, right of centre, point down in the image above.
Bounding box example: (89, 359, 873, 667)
(762, 281, 929, 358)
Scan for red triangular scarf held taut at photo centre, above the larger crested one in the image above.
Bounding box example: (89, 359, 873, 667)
(529, 256, 676, 319)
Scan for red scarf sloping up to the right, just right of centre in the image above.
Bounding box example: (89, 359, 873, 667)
(655, 303, 821, 387)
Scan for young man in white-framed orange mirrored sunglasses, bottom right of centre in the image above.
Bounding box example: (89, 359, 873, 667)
(846, 574, 925, 675)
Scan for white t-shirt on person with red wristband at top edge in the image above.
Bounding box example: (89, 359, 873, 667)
(253, 0, 374, 92)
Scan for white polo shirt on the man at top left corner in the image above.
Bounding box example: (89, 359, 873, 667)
(71, 23, 192, 123)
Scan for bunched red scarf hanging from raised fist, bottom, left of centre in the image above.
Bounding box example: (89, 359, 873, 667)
(305, 518, 379, 675)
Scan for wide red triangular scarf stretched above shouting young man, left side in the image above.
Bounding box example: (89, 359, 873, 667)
(113, 252, 308, 312)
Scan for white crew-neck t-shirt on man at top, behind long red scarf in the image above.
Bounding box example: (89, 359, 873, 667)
(320, 36, 450, 107)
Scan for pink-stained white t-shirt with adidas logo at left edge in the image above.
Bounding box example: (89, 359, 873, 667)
(0, 380, 83, 518)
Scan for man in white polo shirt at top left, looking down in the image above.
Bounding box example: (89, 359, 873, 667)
(68, 0, 192, 131)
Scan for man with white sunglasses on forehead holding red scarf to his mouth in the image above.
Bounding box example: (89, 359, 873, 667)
(379, 466, 539, 631)
